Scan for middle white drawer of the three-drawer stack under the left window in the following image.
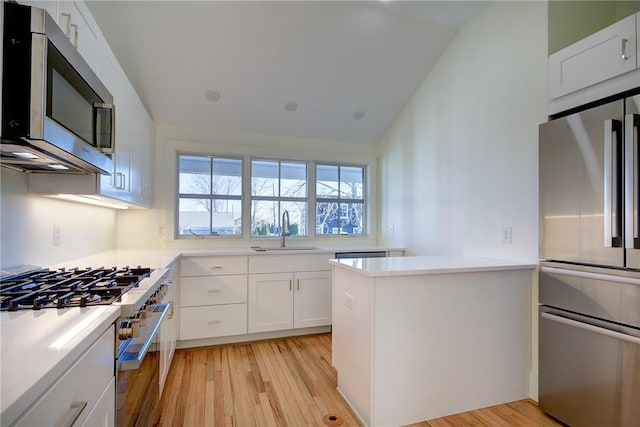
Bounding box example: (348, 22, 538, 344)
(180, 274, 247, 307)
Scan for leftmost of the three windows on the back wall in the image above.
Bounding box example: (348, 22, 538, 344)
(178, 155, 242, 236)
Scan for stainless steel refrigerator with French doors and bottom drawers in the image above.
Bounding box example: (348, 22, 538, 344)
(539, 91, 640, 427)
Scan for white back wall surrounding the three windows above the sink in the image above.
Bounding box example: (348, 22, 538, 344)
(118, 123, 378, 248)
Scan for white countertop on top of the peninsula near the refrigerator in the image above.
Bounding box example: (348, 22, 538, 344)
(329, 256, 536, 277)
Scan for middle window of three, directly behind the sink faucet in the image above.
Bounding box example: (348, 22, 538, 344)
(251, 160, 308, 236)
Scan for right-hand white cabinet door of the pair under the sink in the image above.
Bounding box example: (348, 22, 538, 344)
(293, 271, 331, 328)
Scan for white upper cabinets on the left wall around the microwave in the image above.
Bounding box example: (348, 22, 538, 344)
(20, 0, 153, 207)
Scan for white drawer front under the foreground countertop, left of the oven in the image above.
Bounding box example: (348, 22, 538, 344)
(17, 326, 115, 426)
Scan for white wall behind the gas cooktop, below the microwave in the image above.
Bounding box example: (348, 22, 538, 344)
(0, 168, 116, 268)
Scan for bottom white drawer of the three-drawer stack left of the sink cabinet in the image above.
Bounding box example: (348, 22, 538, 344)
(180, 304, 247, 340)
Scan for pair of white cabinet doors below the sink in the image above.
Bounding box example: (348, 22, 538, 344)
(248, 271, 331, 333)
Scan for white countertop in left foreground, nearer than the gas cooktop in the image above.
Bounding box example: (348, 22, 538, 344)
(0, 305, 120, 425)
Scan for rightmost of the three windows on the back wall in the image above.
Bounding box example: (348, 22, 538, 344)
(316, 164, 365, 235)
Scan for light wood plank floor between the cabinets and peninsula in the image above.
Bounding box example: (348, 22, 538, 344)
(158, 334, 560, 427)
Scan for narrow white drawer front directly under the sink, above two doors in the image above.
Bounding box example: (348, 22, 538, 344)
(249, 253, 333, 274)
